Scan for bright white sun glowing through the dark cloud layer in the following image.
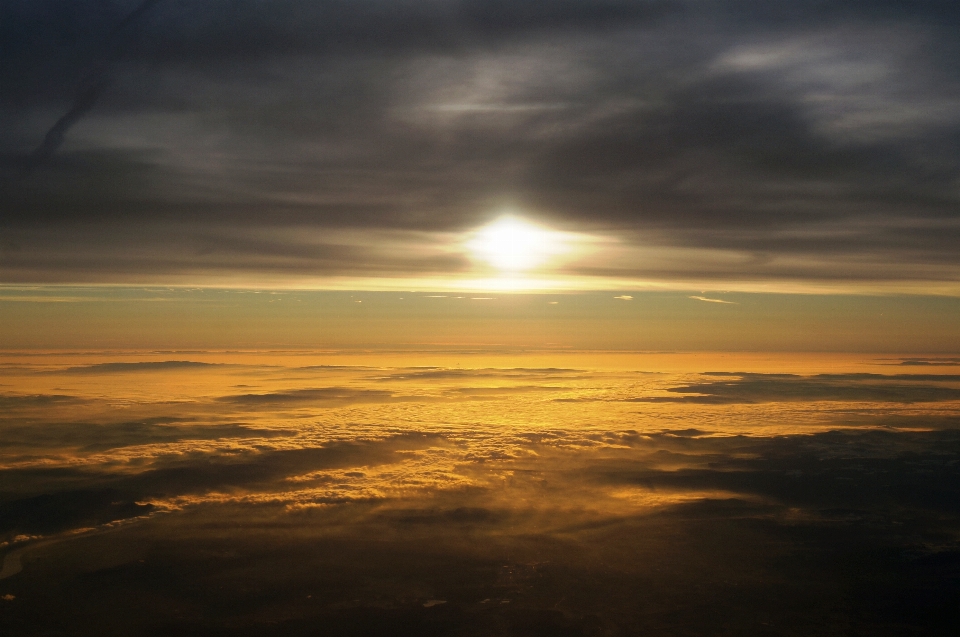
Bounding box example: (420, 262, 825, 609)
(466, 216, 570, 272)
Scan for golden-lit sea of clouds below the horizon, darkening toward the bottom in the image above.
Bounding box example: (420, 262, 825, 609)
(0, 352, 960, 634)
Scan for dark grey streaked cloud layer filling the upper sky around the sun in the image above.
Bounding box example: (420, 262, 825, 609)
(0, 0, 960, 292)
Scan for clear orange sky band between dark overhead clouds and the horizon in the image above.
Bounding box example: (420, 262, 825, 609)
(0, 287, 960, 354)
